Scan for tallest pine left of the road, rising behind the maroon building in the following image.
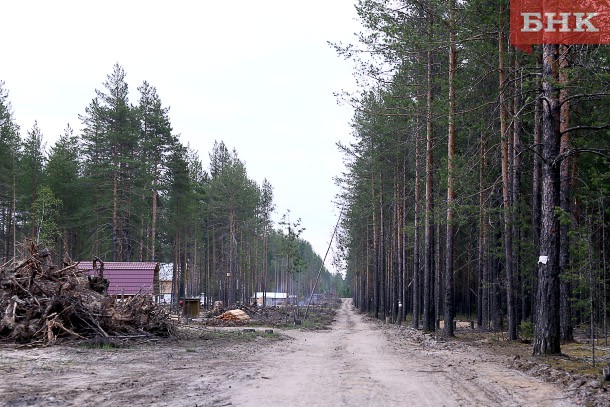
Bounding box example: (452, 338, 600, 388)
(81, 64, 140, 261)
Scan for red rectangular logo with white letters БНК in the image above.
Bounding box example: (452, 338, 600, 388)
(510, 0, 610, 53)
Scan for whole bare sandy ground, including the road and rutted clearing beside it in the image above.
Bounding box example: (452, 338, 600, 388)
(0, 300, 610, 407)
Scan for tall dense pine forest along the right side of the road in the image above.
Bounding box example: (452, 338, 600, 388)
(332, 0, 610, 354)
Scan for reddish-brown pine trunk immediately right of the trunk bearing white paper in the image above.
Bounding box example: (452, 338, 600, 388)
(559, 45, 574, 341)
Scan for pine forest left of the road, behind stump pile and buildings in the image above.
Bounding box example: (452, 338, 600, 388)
(0, 64, 343, 305)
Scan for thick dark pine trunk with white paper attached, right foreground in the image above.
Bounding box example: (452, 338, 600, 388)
(533, 44, 561, 355)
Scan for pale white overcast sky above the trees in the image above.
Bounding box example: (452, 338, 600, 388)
(0, 0, 359, 276)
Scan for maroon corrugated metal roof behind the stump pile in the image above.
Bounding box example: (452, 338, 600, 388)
(78, 261, 158, 295)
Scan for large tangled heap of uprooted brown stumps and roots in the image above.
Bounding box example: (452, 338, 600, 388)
(0, 244, 174, 346)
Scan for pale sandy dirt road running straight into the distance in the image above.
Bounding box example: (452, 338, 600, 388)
(232, 300, 573, 407)
